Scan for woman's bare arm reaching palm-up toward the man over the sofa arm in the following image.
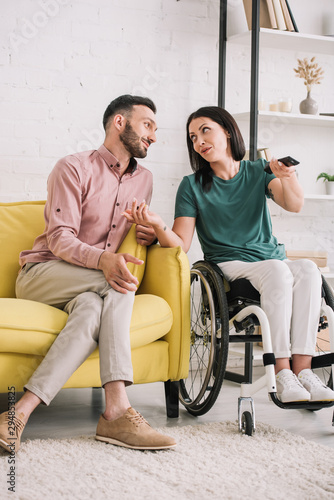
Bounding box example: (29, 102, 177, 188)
(123, 200, 196, 252)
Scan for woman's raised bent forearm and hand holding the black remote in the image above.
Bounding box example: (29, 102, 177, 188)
(268, 159, 304, 212)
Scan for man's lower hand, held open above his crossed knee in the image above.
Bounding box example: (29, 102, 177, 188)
(98, 252, 144, 293)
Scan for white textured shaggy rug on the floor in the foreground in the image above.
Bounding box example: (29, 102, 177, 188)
(0, 422, 334, 500)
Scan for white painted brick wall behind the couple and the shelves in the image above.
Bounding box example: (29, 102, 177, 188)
(0, 0, 334, 268)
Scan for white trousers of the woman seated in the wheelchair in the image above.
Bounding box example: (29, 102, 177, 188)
(218, 259, 321, 358)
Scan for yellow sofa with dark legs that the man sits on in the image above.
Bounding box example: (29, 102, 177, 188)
(0, 201, 190, 417)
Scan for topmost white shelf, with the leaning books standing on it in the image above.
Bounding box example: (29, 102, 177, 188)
(228, 28, 334, 55)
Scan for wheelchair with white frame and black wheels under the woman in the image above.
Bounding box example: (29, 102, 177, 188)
(179, 261, 334, 436)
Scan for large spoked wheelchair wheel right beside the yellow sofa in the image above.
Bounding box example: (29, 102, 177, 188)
(180, 261, 229, 416)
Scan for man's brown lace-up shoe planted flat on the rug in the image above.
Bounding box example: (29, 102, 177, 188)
(95, 407, 176, 450)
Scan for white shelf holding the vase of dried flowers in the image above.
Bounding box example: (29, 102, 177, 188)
(233, 111, 334, 127)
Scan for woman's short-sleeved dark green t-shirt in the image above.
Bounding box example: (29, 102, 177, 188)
(175, 159, 286, 263)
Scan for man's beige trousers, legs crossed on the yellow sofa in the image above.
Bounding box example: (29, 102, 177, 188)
(16, 260, 134, 405)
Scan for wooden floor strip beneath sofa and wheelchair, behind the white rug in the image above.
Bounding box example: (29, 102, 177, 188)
(0, 368, 334, 448)
